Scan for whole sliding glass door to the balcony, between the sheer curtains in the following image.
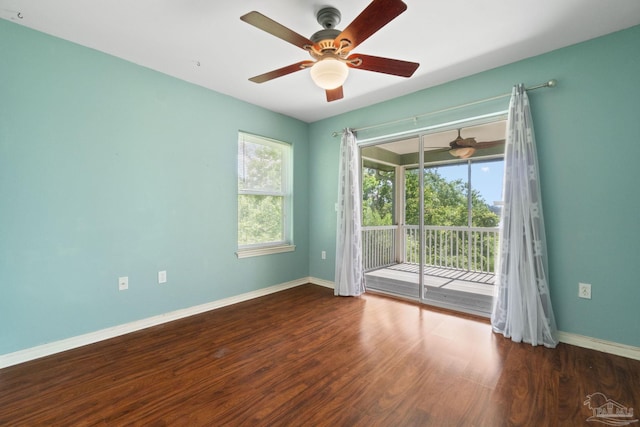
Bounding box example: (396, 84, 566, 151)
(361, 117, 505, 315)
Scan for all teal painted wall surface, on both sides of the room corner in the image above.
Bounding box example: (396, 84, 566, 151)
(0, 20, 640, 354)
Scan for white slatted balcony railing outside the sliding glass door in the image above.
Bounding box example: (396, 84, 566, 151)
(362, 225, 498, 273)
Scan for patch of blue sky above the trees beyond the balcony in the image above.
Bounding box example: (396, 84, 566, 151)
(437, 159, 504, 205)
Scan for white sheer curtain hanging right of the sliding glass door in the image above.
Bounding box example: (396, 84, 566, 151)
(491, 84, 558, 347)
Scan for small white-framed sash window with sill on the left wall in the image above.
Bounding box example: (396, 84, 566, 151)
(237, 132, 295, 258)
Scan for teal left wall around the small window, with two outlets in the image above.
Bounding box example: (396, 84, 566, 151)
(0, 20, 309, 354)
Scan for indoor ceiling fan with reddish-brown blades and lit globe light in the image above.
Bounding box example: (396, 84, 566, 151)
(240, 0, 420, 102)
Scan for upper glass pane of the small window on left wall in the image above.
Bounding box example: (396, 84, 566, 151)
(238, 139, 286, 193)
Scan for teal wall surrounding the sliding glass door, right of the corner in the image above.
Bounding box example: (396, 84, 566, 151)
(309, 26, 640, 346)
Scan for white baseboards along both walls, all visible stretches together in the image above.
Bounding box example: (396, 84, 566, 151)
(0, 277, 640, 369)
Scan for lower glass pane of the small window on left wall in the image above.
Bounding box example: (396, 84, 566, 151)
(238, 194, 284, 246)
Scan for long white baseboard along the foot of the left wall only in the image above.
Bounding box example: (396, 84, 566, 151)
(0, 277, 312, 369)
